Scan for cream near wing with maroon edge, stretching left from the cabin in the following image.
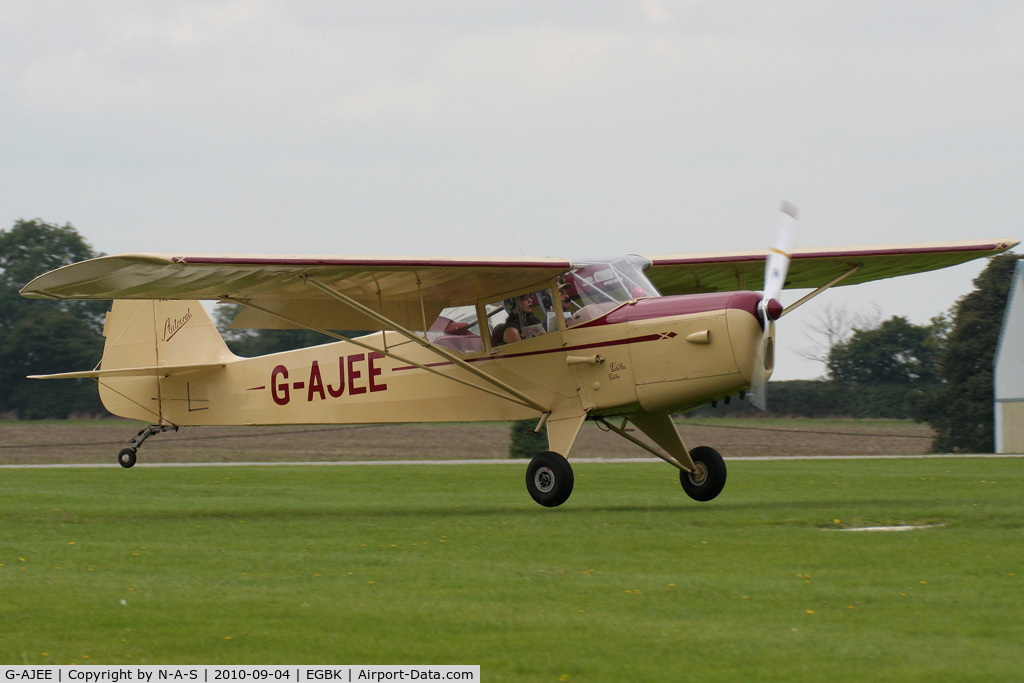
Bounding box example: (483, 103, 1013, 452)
(22, 254, 572, 330)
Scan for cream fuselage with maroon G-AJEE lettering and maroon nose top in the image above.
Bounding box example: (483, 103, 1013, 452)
(101, 292, 770, 425)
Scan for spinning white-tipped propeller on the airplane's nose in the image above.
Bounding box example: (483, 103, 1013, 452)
(751, 202, 797, 411)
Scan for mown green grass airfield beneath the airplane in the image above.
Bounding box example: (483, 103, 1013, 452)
(0, 459, 1024, 683)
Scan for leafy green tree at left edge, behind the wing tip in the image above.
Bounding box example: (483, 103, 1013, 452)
(0, 219, 110, 419)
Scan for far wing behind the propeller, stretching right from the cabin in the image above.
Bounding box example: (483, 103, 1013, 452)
(643, 239, 1019, 296)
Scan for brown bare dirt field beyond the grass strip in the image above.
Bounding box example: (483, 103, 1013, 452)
(0, 420, 932, 464)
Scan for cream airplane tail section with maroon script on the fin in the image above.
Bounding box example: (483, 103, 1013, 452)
(92, 300, 237, 424)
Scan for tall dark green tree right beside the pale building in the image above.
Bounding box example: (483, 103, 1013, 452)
(914, 254, 1020, 453)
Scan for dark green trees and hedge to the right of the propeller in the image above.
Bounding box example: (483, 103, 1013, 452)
(691, 254, 1020, 453)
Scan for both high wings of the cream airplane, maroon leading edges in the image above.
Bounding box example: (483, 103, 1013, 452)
(22, 239, 1018, 330)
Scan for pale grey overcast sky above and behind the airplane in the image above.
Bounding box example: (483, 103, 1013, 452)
(0, 0, 1024, 379)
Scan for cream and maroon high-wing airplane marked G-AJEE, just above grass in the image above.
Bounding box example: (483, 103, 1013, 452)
(20, 204, 1018, 507)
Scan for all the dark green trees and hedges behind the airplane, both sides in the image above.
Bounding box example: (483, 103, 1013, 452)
(0, 219, 1019, 457)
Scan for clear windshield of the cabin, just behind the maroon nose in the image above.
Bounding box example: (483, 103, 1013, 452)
(558, 256, 660, 327)
